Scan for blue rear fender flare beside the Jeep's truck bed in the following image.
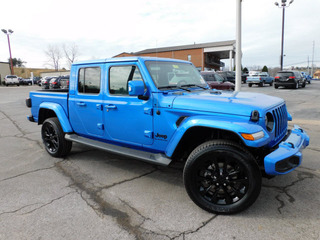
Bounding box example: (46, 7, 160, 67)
(38, 102, 73, 133)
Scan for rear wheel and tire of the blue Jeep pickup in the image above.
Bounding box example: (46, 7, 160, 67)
(41, 117, 72, 157)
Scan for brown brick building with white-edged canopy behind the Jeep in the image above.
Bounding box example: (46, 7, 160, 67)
(114, 40, 236, 71)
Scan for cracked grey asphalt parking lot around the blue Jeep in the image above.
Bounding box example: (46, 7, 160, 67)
(0, 81, 320, 240)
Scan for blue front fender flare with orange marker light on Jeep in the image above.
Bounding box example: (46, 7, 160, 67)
(165, 116, 271, 157)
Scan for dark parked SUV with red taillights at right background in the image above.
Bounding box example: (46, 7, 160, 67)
(274, 71, 306, 89)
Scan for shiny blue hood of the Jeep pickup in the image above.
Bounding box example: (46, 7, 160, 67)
(172, 91, 284, 116)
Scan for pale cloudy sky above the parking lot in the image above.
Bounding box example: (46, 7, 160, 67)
(0, 0, 320, 68)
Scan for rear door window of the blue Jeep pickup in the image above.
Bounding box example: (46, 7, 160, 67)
(78, 67, 101, 94)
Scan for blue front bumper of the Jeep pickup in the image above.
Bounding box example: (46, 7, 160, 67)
(264, 125, 309, 175)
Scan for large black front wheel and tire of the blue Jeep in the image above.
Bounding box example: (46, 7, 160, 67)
(183, 140, 261, 214)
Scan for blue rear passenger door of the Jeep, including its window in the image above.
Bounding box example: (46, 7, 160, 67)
(69, 64, 105, 138)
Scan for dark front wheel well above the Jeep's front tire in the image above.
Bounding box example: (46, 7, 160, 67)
(172, 127, 243, 161)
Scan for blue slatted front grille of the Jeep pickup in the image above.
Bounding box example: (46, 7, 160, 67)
(272, 104, 288, 142)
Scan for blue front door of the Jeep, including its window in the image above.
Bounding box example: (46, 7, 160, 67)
(103, 63, 153, 145)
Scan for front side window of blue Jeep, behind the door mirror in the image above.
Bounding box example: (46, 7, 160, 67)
(109, 65, 143, 95)
